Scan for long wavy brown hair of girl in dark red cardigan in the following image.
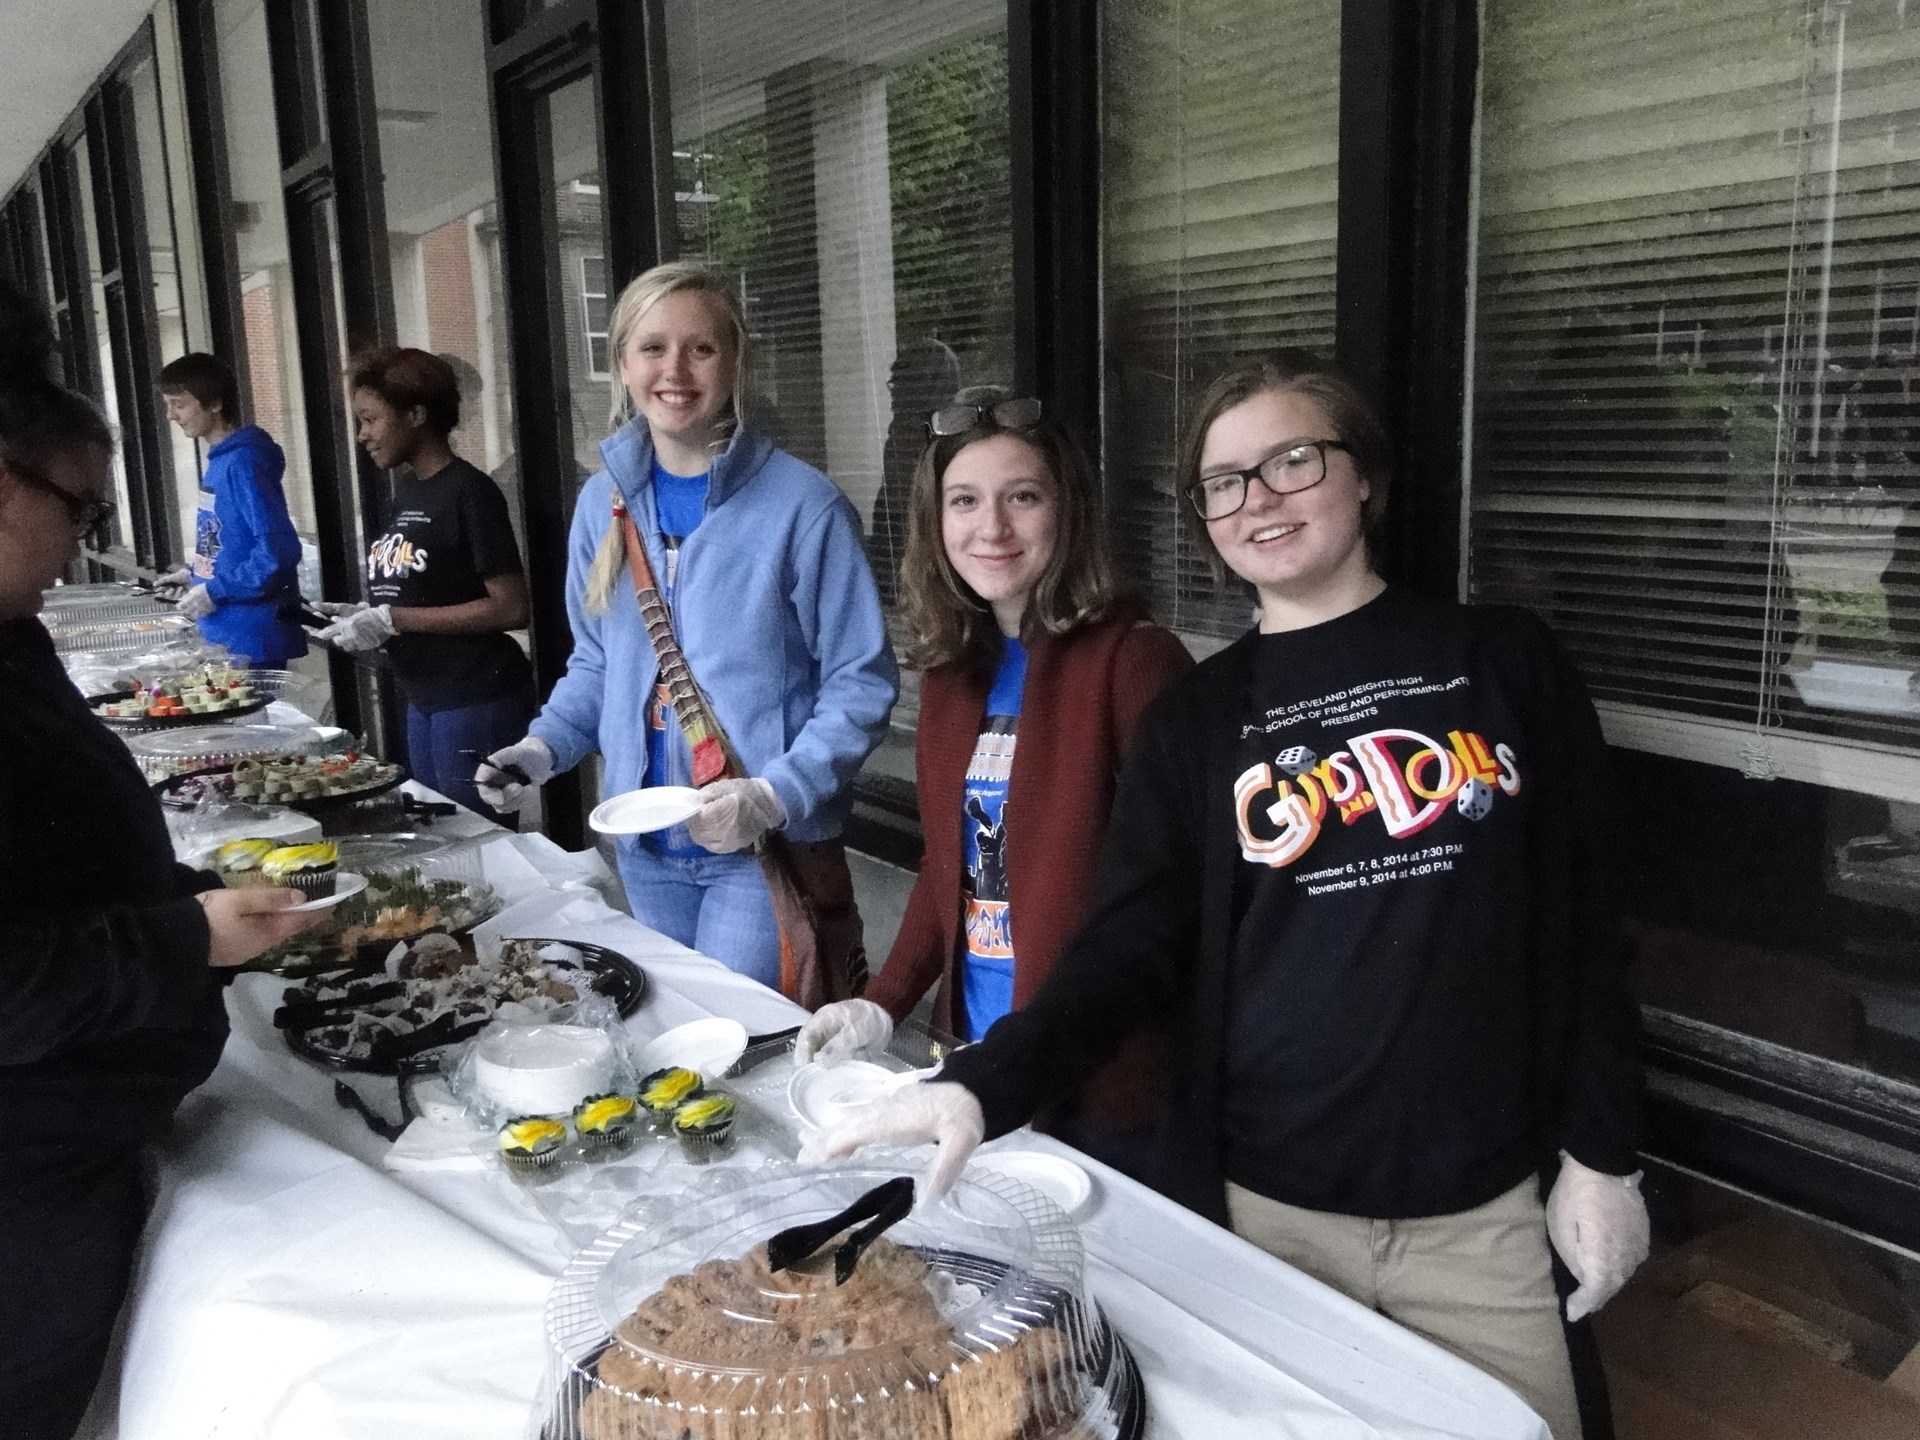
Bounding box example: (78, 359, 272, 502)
(900, 386, 1121, 670)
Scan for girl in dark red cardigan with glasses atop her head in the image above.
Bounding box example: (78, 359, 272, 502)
(799, 392, 1192, 1158)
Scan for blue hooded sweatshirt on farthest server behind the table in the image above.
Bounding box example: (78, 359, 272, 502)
(192, 424, 307, 664)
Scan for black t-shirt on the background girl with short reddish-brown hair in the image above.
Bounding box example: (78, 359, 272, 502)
(367, 457, 534, 710)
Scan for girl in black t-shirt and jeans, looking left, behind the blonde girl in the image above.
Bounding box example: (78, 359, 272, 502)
(321, 349, 534, 828)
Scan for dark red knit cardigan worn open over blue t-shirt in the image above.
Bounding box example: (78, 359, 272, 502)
(866, 607, 1192, 1131)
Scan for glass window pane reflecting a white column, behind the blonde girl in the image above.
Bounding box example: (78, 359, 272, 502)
(660, 0, 1014, 781)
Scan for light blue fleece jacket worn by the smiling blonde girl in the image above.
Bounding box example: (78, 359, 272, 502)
(532, 419, 899, 841)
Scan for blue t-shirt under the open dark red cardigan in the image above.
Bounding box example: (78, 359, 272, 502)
(960, 639, 1027, 1041)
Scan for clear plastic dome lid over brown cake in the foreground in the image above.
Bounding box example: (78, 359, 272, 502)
(538, 1165, 1142, 1440)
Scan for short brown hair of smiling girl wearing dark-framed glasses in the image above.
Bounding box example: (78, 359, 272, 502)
(1173, 349, 1394, 582)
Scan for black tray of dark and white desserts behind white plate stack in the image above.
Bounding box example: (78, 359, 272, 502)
(273, 935, 647, 1075)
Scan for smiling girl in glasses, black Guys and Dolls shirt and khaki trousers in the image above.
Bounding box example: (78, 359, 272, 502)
(803, 351, 1647, 1440)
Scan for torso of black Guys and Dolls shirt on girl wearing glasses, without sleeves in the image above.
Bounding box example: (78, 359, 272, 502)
(1223, 591, 1563, 1215)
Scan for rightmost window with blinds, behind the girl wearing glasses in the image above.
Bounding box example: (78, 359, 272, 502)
(1467, 0, 1920, 801)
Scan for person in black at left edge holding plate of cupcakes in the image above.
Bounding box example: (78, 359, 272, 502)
(0, 278, 319, 1440)
